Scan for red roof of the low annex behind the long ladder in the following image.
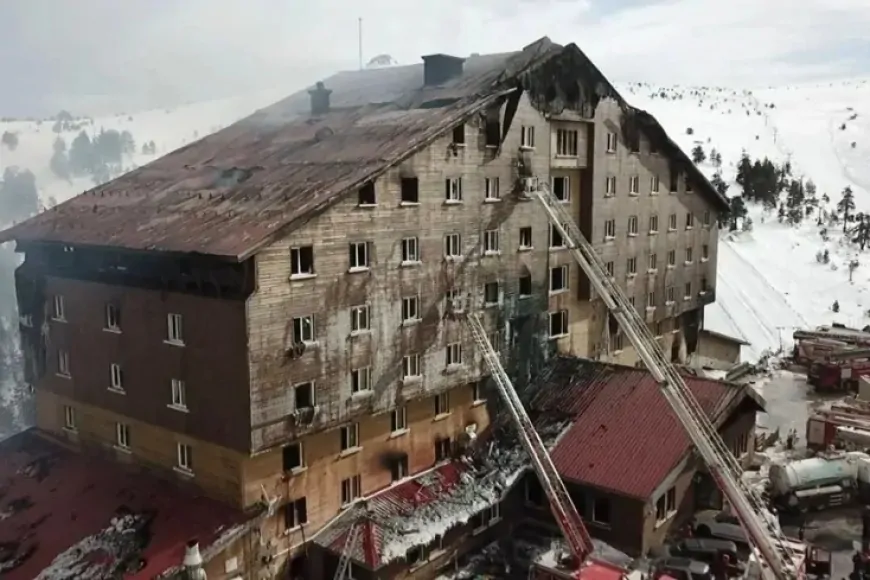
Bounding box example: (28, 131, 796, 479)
(532, 357, 745, 499)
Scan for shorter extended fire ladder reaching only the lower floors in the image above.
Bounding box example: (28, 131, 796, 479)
(467, 314, 592, 564)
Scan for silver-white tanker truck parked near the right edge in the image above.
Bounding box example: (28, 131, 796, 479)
(769, 452, 870, 513)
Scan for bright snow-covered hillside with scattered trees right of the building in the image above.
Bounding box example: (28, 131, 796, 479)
(621, 80, 870, 358)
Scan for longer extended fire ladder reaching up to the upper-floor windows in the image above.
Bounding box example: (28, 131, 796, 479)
(528, 183, 800, 580)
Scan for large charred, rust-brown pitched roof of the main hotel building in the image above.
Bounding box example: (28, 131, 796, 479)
(0, 38, 727, 260)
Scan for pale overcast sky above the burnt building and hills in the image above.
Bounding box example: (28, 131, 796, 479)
(0, 0, 870, 115)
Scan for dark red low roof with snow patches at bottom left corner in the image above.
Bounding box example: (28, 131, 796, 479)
(0, 430, 252, 580)
